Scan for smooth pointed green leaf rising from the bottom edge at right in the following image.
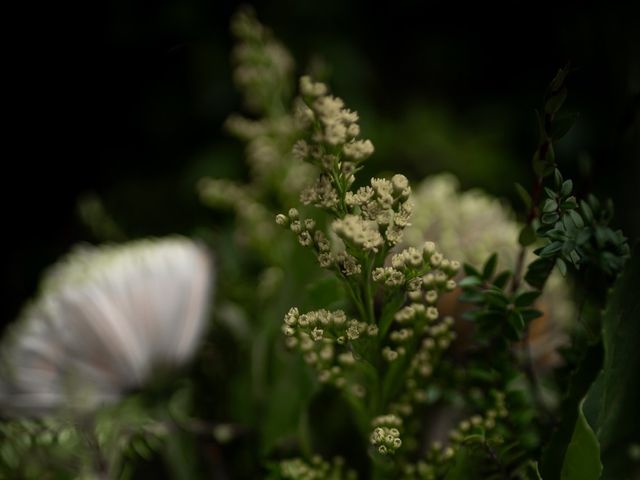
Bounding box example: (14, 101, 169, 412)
(560, 401, 602, 480)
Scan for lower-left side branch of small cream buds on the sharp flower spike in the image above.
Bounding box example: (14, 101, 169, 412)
(282, 307, 378, 397)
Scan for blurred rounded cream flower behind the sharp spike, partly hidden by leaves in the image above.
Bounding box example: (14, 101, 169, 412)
(404, 174, 573, 366)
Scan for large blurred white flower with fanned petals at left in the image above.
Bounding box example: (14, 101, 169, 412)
(0, 237, 213, 414)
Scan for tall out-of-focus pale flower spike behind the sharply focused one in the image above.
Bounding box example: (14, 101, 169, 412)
(197, 7, 313, 264)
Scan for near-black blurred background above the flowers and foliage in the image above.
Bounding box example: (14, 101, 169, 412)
(0, 0, 640, 324)
